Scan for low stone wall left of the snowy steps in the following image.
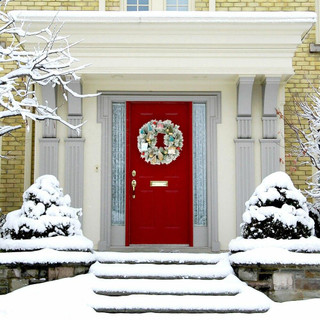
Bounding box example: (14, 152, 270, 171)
(0, 263, 91, 294)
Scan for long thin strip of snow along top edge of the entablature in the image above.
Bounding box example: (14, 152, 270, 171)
(10, 10, 316, 23)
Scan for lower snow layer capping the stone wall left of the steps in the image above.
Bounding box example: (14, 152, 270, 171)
(0, 249, 95, 264)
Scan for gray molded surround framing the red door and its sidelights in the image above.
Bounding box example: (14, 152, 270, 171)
(97, 92, 221, 251)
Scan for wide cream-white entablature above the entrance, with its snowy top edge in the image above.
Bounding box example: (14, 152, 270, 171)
(11, 11, 316, 79)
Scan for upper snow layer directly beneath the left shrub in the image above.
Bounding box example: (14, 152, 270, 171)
(0, 236, 93, 251)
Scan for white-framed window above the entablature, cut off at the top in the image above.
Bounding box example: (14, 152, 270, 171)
(124, 0, 195, 11)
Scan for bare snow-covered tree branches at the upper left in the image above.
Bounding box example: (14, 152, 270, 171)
(0, 0, 96, 154)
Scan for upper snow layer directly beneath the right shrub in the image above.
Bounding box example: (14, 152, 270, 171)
(229, 237, 320, 252)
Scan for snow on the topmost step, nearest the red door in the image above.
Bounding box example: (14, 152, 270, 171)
(95, 252, 228, 264)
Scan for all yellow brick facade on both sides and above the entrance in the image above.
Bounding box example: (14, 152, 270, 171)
(0, 0, 320, 213)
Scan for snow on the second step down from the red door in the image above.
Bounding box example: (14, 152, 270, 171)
(90, 260, 233, 279)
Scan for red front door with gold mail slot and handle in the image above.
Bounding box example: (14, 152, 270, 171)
(126, 102, 193, 246)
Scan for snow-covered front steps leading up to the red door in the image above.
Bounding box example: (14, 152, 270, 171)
(90, 252, 270, 313)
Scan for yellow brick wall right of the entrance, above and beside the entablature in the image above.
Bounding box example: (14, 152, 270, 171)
(216, 0, 320, 190)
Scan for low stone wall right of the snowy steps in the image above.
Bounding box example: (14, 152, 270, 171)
(233, 264, 320, 302)
